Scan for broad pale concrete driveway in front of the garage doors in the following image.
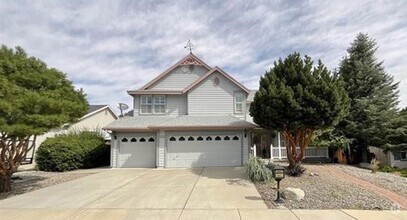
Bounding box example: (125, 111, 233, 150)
(0, 168, 267, 220)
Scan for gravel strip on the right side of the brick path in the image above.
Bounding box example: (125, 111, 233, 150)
(337, 165, 407, 198)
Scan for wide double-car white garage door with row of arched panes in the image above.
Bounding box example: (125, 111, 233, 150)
(167, 132, 242, 167)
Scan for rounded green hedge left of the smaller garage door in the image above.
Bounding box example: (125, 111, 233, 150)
(35, 131, 110, 172)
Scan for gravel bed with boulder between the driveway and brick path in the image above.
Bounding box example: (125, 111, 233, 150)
(256, 165, 406, 210)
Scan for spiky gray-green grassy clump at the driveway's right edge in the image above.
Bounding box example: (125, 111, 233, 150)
(245, 157, 273, 182)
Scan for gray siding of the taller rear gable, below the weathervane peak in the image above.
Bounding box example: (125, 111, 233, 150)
(148, 66, 208, 90)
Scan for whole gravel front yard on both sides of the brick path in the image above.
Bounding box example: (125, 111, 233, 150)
(256, 164, 407, 210)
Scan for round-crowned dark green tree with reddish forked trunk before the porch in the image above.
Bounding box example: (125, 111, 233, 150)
(250, 53, 348, 168)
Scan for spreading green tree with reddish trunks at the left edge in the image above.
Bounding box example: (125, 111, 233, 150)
(0, 46, 87, 193)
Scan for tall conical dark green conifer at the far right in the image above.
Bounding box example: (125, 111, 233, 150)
(337, 33, 398, 162)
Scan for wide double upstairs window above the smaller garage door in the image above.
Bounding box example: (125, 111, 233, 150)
(140, 95, 165, 114)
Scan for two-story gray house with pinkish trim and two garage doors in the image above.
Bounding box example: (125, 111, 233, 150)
(104, 53, 256, 167)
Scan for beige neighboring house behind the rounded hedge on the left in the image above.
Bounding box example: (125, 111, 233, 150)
(27, 105, 118, 162)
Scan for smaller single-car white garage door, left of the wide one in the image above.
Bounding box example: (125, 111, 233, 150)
(118, 133, 156, 167)
